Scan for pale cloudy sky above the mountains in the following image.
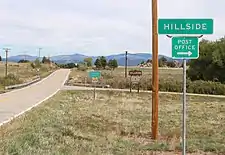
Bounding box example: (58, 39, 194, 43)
(0, 0, 225, 56)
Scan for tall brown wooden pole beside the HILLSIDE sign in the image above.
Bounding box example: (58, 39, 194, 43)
(152, 0, 159, 140)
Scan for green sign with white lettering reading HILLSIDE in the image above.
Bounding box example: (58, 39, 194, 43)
(158, 19, 213, 34)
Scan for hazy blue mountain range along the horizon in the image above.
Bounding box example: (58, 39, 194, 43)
(3, 53, 176, 66)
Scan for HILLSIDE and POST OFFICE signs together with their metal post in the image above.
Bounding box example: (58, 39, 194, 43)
(158, 19, 214, 155)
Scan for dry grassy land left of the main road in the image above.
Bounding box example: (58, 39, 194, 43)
(0, 62, 59, 90)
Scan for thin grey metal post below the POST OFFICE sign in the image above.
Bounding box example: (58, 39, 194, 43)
(182, 59, 187, 155)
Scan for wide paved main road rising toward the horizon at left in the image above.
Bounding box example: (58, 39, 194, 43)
(0, 69, 70, 125)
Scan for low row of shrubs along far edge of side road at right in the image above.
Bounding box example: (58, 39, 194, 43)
(98, 73, 225, 95)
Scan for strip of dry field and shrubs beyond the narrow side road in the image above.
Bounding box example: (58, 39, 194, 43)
(67, 67, 225, 95)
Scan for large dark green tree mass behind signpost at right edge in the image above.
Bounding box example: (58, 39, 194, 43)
(187, 37, 225, 83)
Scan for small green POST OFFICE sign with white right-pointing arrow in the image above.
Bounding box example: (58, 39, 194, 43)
(172, 37, 199, 59)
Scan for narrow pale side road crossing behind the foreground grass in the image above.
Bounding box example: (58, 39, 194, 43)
(61, 86, 225, 98)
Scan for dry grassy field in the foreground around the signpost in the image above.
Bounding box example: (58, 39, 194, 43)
(0, 91, 225, 155)
